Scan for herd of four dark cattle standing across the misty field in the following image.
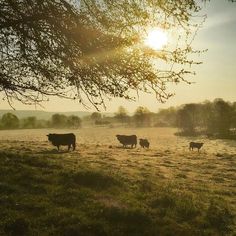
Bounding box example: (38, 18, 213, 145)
(47, 133, 203, 152)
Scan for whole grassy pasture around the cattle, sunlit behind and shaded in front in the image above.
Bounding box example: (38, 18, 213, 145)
(0, 128, 236, 236)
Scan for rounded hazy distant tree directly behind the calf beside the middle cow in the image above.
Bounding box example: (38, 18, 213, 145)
(133, 106, 152, 127)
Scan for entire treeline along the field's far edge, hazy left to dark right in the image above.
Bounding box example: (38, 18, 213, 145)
(0, 99, 236, 138)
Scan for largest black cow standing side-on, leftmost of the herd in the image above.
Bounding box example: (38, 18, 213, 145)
(47, 133, 76, 151)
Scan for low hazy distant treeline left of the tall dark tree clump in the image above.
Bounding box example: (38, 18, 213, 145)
(0, 106, 170, 129)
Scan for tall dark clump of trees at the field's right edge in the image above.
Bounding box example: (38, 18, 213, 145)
(176, 99, 236, 138)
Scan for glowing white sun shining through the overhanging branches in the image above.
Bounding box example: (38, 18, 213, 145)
(144, 28, 168, 50)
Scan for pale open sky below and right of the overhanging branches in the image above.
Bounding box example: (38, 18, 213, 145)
(0, 0, 236, 113)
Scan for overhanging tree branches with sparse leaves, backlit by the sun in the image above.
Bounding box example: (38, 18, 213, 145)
(0, 0, 210, 108)
